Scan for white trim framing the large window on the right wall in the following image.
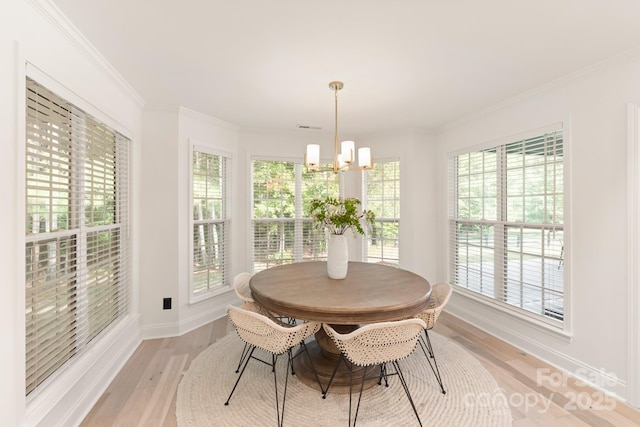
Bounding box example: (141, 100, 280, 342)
(445, 122, 572, 341)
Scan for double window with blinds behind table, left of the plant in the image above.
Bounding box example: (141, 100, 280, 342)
(251, 160, 340, 272)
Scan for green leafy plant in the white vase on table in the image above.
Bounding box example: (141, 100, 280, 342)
(310, 197, 375, 235)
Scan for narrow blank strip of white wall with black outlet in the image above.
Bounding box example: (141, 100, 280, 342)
(139, 106, 180, 338)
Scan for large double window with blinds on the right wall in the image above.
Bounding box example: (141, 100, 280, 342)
(449, 128, 564, 324)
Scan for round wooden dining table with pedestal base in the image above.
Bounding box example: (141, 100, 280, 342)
(249, 261, 431, 392)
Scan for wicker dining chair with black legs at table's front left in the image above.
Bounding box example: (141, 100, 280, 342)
(225, 306, 324, 426)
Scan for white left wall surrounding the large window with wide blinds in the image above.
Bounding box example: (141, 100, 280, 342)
(0, 0, 142, 425)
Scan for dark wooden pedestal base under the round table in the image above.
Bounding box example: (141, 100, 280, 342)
(293, 326, 380, 394)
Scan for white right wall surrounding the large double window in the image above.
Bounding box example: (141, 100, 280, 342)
(437, 51, 640, 399)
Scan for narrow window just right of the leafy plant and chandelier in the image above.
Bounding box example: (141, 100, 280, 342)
(362, 160, 400, 264)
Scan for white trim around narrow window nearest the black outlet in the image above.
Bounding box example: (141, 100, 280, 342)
(187, 142, 233, 304)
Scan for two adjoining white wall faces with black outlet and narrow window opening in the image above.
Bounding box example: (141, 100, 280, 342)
(140, 105, 241, 338)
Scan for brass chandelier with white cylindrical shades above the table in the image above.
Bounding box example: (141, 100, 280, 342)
(304, 82, 373, 173)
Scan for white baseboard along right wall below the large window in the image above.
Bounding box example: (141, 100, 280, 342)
(447, 304, 627, 403)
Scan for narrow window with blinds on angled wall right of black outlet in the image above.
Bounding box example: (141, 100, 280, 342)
(191, 147, 231, 300)
